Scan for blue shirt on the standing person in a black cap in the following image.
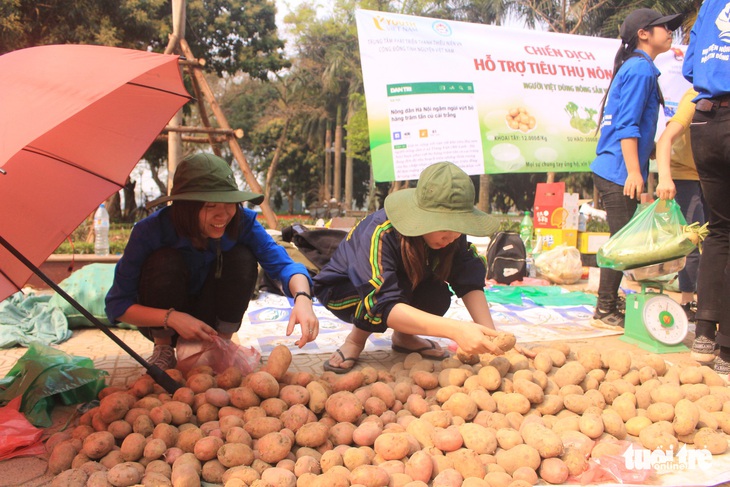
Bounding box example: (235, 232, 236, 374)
(591, 49, 661, 186)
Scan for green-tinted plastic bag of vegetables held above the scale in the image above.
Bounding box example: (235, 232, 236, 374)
(596, 200, 692, 271)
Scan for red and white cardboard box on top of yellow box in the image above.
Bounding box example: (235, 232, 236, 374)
(533, 182, 579, 230)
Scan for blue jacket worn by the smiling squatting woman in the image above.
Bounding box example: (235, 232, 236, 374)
(106, 206, 309, 323)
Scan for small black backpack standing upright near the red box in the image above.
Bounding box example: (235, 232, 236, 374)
(487, 232, 527, 284)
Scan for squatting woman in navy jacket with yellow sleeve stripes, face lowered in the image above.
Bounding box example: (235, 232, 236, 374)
(314, 162, 512, 374)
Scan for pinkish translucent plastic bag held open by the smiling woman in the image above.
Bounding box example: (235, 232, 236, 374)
(175, 336, 261, 375)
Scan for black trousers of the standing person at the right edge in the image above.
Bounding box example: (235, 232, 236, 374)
(690, 102, 730, 346)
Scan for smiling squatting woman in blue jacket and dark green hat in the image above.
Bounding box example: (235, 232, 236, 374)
(106, 154, 319, 370)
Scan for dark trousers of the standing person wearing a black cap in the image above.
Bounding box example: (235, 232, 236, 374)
(593, 174, 638, 313)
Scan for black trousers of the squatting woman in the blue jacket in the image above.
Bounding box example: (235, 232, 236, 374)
(139, 245, 258, 343)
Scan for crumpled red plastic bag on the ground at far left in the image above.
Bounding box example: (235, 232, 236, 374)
(0, 396, 46, 461)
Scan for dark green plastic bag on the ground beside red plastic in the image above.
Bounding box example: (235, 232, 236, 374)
(0, 342, 108, 427)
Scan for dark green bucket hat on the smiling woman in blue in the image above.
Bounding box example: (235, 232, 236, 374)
(147, 154, 264, 208)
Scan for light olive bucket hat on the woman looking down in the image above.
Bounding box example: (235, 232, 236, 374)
(385, 162, 499, 237)
